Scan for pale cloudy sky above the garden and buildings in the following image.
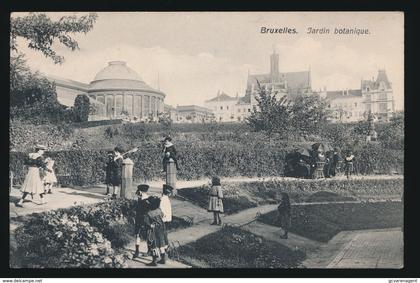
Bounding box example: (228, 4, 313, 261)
(12, 12, 404, 109)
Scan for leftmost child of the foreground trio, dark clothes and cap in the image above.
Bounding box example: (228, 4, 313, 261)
(133, 184, 149, 257)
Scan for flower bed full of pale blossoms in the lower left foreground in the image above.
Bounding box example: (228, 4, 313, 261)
(10, 199, 190, 268)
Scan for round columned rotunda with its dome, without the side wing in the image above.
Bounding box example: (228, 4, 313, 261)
(87, 61, 165, 119)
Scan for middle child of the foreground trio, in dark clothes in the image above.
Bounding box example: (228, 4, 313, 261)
(144, 196, 169, 266)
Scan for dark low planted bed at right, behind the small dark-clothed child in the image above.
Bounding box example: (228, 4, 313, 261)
(260, 202, 404, 242)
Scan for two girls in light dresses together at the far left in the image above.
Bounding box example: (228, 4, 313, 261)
(15, 145, 57, 207)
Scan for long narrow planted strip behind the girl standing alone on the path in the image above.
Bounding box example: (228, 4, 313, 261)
(178, 178, 404, 214)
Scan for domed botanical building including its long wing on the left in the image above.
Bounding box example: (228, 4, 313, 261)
(46, 61, 165, 120)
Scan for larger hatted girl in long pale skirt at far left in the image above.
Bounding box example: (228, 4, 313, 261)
(15, 145, 49, 207)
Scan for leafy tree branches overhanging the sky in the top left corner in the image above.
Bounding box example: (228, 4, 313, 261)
(10, 13, 97, 64)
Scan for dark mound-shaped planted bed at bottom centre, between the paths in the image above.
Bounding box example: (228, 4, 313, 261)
(180, 227, 306, 268)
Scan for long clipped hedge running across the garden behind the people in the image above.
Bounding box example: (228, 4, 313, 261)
(9, 141, 403, 186)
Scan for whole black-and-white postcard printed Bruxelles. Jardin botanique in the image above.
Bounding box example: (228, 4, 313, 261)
(9, 12, 404, 270)
